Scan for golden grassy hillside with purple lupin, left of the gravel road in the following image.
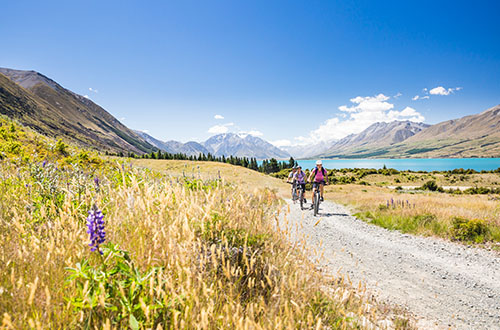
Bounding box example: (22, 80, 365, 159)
(0, 119, 408, 329)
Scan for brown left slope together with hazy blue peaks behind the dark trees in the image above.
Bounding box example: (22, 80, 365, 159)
(0, 68, 290, 159)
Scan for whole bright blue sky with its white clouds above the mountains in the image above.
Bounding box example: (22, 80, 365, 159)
(0, 0, 500, 145)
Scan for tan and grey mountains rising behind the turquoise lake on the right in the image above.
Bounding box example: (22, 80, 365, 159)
(316, 105, 500, 158)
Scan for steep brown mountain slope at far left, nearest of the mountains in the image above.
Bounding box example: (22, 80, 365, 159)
(0, 68, 155, 154)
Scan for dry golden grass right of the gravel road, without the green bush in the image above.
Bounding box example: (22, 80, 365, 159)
(325, 184, 500, 240)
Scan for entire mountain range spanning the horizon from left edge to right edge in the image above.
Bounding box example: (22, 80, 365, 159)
(0, 68, 500, 159)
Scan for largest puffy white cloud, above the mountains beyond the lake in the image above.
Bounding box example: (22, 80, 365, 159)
(288, 94, 425, 145)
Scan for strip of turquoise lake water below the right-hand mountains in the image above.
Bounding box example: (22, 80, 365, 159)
(297, 158, 500, 172)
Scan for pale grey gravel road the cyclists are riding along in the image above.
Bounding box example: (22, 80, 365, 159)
(286, 201, 500, 329)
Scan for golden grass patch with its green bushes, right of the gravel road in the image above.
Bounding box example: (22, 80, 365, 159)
(327, 185, 500, 244)
